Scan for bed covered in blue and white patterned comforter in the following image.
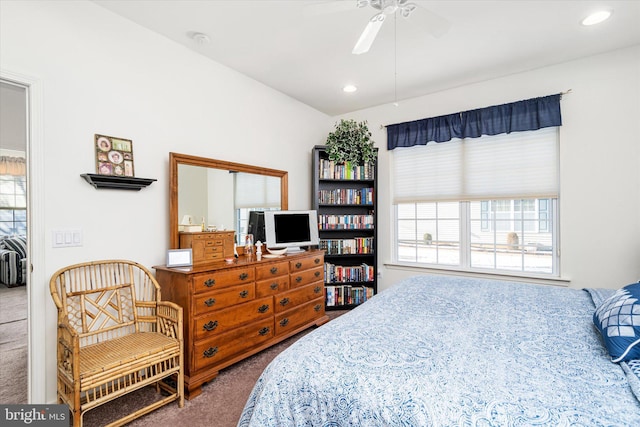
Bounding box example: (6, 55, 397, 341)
(238, 276, 640, 427)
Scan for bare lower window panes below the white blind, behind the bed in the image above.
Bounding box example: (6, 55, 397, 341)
(396, 199, 556, 274)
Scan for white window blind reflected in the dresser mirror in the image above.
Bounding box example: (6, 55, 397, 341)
(234, 173, 280, 209)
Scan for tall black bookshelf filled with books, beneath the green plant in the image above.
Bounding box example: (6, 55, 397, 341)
(312, 145, 378, 310)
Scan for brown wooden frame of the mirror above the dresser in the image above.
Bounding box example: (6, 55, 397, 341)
(169, 153, 289, 249)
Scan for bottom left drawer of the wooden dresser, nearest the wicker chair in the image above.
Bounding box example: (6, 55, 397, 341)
(192, 318, 273, 369)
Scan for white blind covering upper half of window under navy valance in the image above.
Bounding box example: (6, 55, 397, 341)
(391, 127, 558, 204)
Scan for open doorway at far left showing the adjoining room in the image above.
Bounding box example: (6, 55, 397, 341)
(0, 80, 29, 404)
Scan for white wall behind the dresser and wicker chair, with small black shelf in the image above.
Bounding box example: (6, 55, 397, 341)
(0, 0, 331, 403)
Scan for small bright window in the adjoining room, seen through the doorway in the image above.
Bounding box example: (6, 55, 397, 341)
(0, 175, 27, 236)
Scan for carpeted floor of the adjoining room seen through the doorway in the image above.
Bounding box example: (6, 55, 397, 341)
(0, 283, 28, 404)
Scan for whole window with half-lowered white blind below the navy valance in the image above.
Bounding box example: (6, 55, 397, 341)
(392, 128, 559, 275)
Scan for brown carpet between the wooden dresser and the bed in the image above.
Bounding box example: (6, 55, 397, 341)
(84, 311, 346, 427)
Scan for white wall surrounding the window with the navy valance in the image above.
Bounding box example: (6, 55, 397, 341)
(334, 46, 640, 289)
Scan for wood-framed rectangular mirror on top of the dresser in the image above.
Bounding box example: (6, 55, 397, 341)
(169, 153, 288, 249)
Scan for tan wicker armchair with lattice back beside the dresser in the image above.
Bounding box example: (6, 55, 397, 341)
(49, 260, 184, 427)
